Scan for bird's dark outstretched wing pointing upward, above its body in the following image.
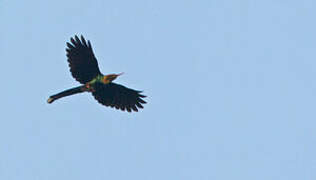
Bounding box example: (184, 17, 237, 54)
(66, 36, 101, 84)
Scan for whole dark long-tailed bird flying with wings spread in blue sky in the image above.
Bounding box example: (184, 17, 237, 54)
(47, 35, 147, 112)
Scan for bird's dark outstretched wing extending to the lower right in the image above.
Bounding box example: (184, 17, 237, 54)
(92, 83, 146, 112)
